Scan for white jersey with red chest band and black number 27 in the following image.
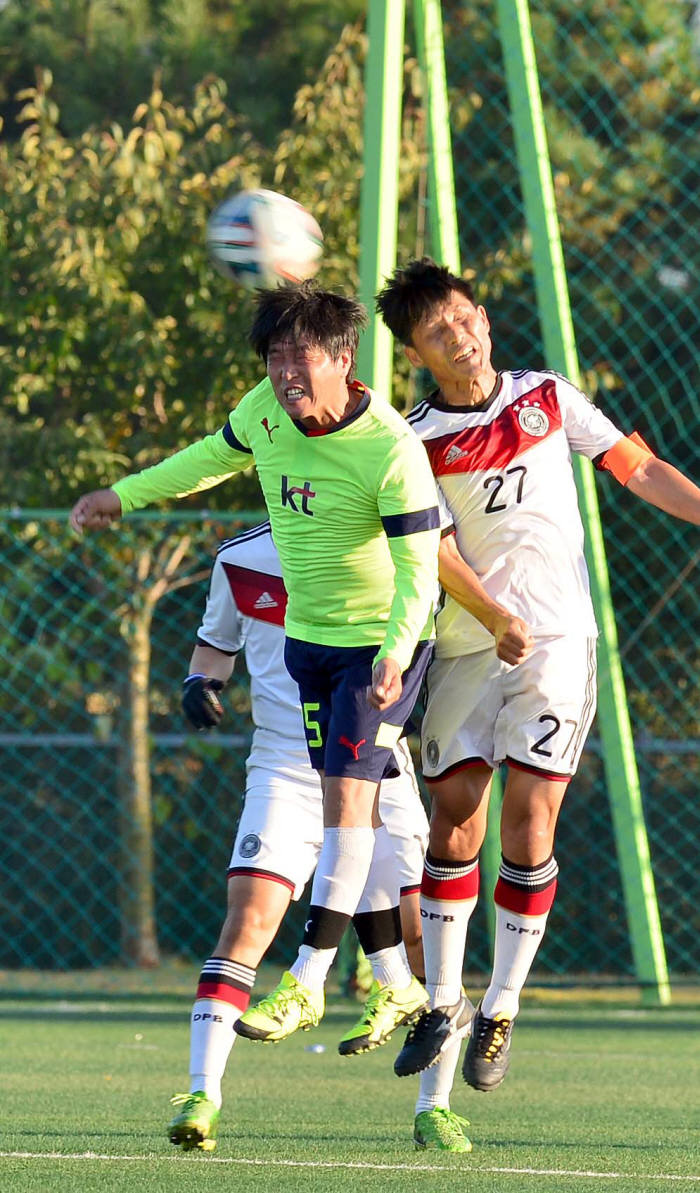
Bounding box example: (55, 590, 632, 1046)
(408, 370, 624, 657)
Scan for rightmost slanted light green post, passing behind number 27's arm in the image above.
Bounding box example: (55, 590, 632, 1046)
(497, 0, 670, 1005)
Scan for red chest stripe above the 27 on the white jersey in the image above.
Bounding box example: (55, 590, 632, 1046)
(423, 381, 562, 476)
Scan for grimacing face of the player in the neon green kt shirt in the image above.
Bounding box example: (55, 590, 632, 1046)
(267, 339, 351, 420)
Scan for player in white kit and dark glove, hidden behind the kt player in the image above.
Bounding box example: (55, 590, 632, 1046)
(168, 523, 428, 1150)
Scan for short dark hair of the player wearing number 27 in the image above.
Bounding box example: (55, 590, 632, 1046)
(377, 256, 476, 344)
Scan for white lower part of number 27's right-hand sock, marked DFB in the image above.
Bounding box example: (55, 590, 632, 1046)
(482, 905, 550, 1019)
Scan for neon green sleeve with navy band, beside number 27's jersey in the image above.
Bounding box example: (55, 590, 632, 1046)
(374, 433, 440, 670)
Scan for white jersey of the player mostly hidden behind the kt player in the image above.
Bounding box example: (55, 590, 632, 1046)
(197, 523, 309, 767)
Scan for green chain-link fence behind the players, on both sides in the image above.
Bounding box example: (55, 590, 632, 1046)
(0, 0, 700, 984)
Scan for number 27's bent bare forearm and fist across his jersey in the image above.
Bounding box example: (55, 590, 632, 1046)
(438, 534, 534, 666)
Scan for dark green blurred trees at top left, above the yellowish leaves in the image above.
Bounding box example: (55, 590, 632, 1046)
(0, 0, 365, 144)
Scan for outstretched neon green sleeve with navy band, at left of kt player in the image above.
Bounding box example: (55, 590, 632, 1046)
(112, 398, 253, 514)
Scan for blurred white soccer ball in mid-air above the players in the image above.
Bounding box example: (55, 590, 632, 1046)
(206, 190, 323, 289)
